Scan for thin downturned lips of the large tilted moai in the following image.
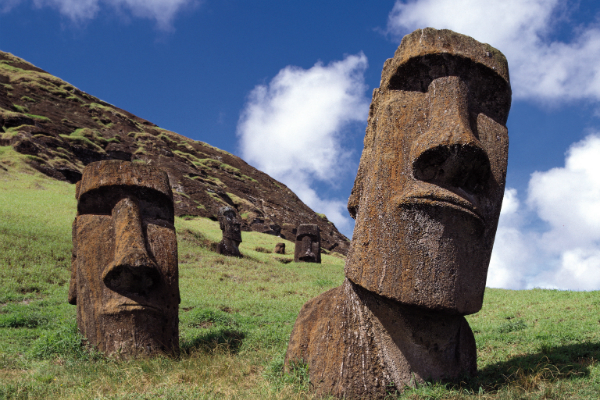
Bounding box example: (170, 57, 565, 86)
(397, 185, 485, 226)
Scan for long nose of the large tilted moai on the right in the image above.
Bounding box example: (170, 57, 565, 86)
(411, 76, 491, 193)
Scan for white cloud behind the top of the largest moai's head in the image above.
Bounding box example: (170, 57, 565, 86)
(387, 0, 600, 102)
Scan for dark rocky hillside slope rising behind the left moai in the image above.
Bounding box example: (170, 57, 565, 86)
(0, 52, 349, 254)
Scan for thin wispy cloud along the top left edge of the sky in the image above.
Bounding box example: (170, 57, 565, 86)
(0, 0, 200, 30)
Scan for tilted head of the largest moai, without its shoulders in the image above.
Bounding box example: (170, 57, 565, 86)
(345, 28, 511, 314)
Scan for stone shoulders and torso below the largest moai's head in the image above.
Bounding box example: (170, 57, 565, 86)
(285, 279, 477, 399)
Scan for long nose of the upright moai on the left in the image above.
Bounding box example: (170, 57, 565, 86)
(102, 196, 160, 293)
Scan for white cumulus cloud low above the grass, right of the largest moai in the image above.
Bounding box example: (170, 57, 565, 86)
(488, 134, 600, 290)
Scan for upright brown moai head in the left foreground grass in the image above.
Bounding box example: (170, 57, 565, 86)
(69, 160, 180, 356)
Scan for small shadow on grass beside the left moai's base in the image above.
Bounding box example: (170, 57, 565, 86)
(180, 328, 246, 354)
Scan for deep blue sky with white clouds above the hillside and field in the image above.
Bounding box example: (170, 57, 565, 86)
(0, 0, 600, 290)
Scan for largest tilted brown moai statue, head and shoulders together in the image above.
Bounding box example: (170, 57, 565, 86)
(286, 28, 511, 398)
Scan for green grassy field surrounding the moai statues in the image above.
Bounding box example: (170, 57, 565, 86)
(0, 154, 600, 399)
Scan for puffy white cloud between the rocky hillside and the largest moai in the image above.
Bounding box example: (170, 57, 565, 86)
(237, 53, 369, 234)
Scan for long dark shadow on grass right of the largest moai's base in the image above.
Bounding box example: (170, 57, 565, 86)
(448, 342, 600, 393)
